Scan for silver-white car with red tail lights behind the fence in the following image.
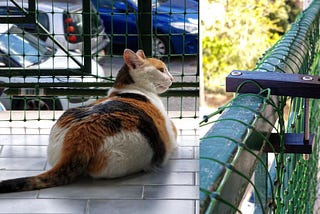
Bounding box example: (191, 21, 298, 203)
(0, 0, 110, 55)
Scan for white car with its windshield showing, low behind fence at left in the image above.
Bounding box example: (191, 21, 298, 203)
(0, 24, 104, 110)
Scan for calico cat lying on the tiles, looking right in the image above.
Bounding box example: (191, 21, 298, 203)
(0, 49, 177, 193)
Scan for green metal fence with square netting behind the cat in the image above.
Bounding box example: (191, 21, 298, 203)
(0, 0, 199, 121)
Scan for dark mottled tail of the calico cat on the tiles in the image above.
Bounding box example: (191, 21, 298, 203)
(0, 153, 89, 193)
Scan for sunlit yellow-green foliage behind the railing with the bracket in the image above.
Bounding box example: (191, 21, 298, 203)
(201, 0, 300, 92)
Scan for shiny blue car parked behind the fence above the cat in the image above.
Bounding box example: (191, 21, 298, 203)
(92, 0, 199, 57)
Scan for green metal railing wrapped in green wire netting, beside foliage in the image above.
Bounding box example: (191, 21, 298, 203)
(200, 1, 320, 213)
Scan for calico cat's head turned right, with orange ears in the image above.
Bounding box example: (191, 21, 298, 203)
(114, 49, 173, 94)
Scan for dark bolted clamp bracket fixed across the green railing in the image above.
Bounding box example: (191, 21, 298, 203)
(226, 70, 320, 154)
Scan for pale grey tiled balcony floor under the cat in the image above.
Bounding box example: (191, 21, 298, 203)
(0, 114, 199, 214)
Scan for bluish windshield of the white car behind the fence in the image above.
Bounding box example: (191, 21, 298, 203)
(0, 26, 53, 67)
